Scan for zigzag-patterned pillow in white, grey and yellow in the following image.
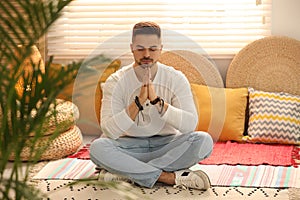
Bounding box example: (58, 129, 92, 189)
(248, 88, 300, 144)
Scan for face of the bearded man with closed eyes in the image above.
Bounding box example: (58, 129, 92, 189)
(131, 34, 162, 66)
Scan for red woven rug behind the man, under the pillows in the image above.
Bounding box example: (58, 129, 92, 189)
(69, 141, 300, 167)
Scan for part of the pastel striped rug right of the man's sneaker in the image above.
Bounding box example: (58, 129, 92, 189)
(191, 165, 300, 188)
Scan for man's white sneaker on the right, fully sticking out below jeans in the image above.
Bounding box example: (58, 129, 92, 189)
(174, 169, 211, 190)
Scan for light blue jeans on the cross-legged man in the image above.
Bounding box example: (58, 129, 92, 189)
(90, 131, 213, 188)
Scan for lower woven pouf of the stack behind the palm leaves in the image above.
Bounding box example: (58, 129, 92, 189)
(10, 126, 82, 161)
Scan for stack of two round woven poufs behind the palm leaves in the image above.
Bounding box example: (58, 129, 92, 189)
(0, 99, 83, 161)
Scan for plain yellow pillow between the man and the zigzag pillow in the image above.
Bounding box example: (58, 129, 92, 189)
(191, 84, 248, 142)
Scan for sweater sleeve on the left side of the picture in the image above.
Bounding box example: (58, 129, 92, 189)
(101, 73, 134, 139)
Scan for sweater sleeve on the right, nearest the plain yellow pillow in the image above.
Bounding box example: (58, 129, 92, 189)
(162, 72, 198, 133)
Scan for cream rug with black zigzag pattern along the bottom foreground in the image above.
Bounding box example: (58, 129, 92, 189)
(38, 180, 290, 200)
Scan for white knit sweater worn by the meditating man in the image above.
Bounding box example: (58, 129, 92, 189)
(101, 63, 198, 139)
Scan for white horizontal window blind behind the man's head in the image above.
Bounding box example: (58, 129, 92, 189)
(47, 0, 271, 62)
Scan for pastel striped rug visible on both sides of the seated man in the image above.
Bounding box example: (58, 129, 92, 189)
(34, 158, 300, 188)
